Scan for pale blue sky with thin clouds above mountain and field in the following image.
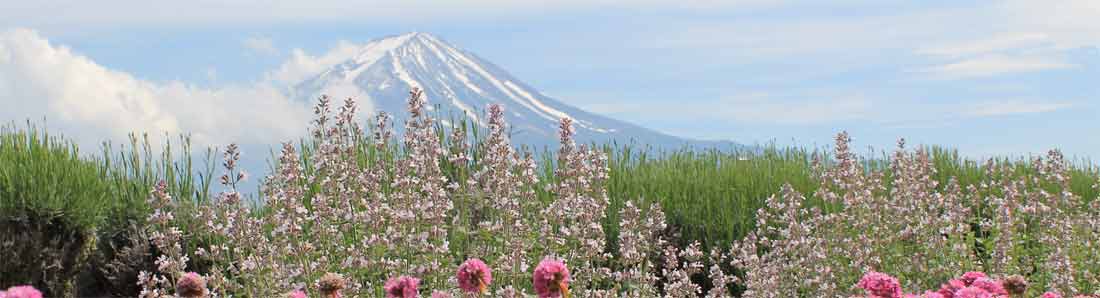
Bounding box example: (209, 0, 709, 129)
(0, 0, 1100, 162)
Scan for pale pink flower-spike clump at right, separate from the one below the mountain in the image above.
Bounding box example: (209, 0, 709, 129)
(733, 133, 1100, 297)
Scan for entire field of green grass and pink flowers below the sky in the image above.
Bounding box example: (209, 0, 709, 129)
(0, 90, 1100, 297)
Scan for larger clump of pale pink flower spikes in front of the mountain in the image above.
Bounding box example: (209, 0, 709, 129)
(140, 90, 682, 297)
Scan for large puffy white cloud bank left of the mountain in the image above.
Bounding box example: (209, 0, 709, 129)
(0, 29, 309, 146)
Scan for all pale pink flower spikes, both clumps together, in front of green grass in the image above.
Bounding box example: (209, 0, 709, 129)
(139, 90, 1100, 298)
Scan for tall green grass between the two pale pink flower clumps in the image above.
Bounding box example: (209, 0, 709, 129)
(603, 146, 816, 252)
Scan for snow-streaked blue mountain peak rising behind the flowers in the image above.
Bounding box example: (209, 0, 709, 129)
(293, 32, 736, 147)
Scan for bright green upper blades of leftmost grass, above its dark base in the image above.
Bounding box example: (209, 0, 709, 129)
(0, 124, 213, 232)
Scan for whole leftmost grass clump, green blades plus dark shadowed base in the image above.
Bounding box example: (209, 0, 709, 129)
(0, 123, 213, 297)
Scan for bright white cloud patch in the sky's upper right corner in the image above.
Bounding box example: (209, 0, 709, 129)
(915, 0, 1100, 78)
